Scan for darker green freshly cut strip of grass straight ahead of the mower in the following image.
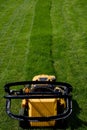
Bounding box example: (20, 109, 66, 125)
(27, 0, 54, 79)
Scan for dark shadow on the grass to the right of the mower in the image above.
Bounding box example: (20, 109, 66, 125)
(68, 100, 87, 130)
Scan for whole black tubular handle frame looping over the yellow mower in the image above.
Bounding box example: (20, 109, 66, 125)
(4, 81, 72, 122)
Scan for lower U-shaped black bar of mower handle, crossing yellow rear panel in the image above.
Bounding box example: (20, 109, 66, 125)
(6, 98, 72, 122)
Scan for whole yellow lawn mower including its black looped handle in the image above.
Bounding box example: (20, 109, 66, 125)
(4, 74, 72, 128)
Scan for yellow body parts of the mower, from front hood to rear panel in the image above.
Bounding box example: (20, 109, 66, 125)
(22, 74, 66, 126)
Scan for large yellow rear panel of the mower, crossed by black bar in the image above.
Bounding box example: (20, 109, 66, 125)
(28, 99, 57, 126)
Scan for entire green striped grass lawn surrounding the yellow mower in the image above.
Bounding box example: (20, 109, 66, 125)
(0, 0, 87, 130)
